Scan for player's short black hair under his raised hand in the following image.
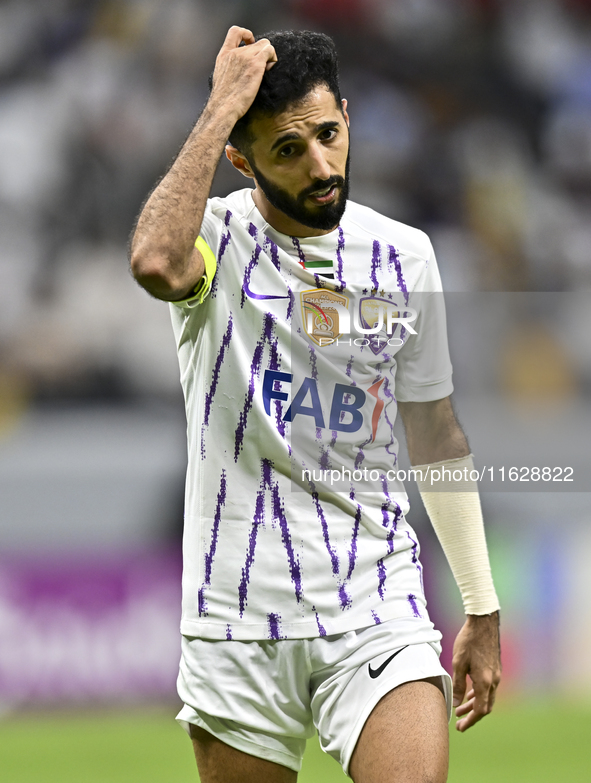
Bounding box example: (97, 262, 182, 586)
(217, 30, 341, 155)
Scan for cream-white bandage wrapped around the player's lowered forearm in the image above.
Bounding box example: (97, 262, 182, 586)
(412, 454, 499, 614)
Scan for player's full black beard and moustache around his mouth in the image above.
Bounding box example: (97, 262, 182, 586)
(249, 154, 350, 231)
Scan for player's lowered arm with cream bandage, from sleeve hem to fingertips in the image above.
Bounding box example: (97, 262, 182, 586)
(398, 397, 501, 731)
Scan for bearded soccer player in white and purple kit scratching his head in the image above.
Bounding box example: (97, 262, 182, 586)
(131, 27, 500, 783)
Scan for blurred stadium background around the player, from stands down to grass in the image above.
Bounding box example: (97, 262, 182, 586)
(0, 0, 591, 783)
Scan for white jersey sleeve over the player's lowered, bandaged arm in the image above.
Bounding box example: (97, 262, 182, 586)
(396, 249, 453, 402)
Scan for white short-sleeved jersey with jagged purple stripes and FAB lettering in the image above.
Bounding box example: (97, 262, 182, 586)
(171, 189, 452, 640)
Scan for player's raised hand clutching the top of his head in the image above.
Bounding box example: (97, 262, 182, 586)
(209, 26, 277, 120)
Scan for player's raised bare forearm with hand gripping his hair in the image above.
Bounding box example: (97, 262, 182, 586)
(130, 27, 277, 301)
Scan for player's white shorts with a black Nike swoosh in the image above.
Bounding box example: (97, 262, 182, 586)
(177, 617, 452, 773)
